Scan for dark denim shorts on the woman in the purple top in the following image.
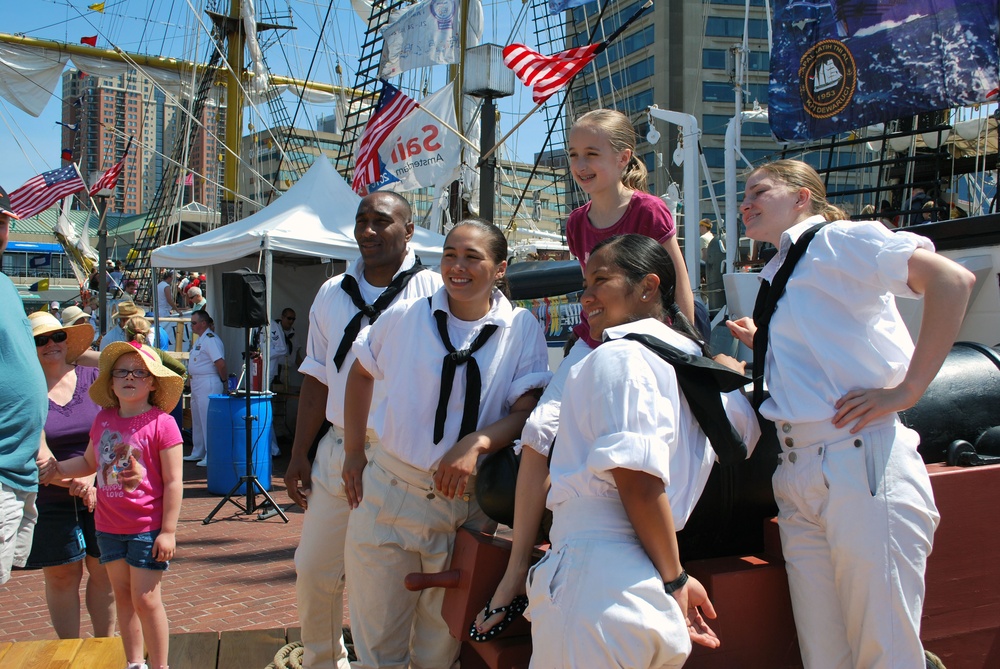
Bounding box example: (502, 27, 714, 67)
(25, 497, 101, 569)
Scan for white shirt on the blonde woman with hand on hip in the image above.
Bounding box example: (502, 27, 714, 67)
(760, 216, 934, 422)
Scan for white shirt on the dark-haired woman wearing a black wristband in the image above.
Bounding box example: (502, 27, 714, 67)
(546, 318, 760, 530)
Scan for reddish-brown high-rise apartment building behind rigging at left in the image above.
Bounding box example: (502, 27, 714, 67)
(62, 70, 225, 214)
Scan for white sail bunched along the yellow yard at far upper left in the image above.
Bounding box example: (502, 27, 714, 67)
(0, 44, 190, 116)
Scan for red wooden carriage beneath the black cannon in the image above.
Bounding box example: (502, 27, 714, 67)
(444, 465, 1000, 669)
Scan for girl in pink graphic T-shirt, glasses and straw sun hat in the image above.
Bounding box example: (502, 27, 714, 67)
(58, 342, 184, 669)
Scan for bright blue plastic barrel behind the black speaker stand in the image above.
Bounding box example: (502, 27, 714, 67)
(207, 393, 272, 495)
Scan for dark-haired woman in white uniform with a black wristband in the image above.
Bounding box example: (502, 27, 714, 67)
(476, 235, 759, 669)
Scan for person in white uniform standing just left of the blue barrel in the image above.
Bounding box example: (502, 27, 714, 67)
(184, 309, 228, 467)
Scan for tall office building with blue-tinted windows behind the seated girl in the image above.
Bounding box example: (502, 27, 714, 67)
(567, 0, 778, 228)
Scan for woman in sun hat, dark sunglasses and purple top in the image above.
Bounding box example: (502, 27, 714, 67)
(26, 307, 115, 639)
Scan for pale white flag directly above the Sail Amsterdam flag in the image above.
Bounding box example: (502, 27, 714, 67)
(379, 0, 483, 79)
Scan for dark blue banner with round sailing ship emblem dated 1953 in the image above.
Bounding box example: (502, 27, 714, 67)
(768, 0, 1000, 141)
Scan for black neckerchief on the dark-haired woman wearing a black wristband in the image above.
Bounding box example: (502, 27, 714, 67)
(623, 332, 750, 465)
